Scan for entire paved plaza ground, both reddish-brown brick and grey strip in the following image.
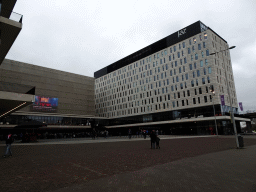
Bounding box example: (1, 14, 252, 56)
(0, 137, 256, 192)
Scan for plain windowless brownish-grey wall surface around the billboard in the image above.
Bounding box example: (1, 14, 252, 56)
(0, 59, 95, 116)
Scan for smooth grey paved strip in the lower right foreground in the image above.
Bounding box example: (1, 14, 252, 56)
(51, 145, 256, 192)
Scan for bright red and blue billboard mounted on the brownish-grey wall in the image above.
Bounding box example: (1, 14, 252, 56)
(30, 96, 59, 112)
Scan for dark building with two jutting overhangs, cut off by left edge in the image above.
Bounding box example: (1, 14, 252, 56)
(0, 0, 35, 123)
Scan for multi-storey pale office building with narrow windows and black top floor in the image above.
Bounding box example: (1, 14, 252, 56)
(94, 21, 248, 134)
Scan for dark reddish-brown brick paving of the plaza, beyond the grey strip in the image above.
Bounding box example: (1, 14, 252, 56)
(0, 137, 256, 192)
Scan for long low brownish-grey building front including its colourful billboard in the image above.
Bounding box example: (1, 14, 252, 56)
(0, 59, 95, 127)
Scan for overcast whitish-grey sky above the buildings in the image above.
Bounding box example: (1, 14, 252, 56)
(6, 0, 256, 110)
